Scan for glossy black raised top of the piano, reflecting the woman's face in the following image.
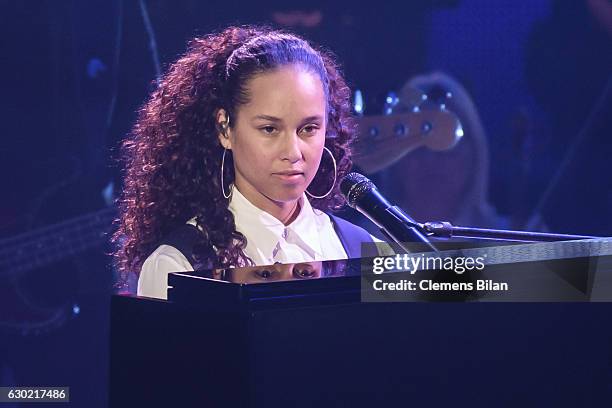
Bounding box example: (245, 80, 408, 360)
(168, 238, 612, 310)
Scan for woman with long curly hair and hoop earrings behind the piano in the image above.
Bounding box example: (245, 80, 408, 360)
(114, 27, 372, 298)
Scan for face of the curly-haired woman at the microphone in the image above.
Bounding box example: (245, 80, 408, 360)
(220, 65, 326, 208)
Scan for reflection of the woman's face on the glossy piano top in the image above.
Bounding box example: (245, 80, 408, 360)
(214, 261, 323, 283)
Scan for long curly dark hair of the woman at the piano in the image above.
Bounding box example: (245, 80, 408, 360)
(113, 26, 355, 284)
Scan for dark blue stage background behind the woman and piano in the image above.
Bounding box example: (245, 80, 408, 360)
(0, 0, 612, 407)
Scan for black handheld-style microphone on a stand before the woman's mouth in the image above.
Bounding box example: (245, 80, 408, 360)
(340, 173, 438, 252)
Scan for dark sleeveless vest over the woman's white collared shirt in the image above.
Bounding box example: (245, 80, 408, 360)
(159, 214, 373, 266)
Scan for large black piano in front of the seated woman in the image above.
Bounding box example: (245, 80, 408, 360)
(110, 241, 612, 407)
